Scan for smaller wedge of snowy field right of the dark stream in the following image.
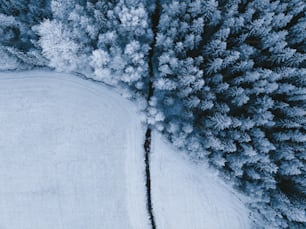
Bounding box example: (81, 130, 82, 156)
(151, 133, 251, 229)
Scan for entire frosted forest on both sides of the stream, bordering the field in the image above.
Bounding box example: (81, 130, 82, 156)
(0, 0, 306, 229)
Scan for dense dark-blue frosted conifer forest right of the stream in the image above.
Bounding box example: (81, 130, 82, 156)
(151, 0, 306, 228)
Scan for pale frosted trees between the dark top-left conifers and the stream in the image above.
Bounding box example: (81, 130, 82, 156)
(36, 0, 152, 97)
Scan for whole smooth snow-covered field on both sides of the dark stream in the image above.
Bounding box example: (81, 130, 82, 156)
(0, 72, 249, 229)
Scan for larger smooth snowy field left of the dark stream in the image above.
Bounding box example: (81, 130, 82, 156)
(0, 71, 150, 229)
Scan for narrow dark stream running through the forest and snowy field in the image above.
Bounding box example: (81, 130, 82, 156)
(144, 0, 161, 229)
